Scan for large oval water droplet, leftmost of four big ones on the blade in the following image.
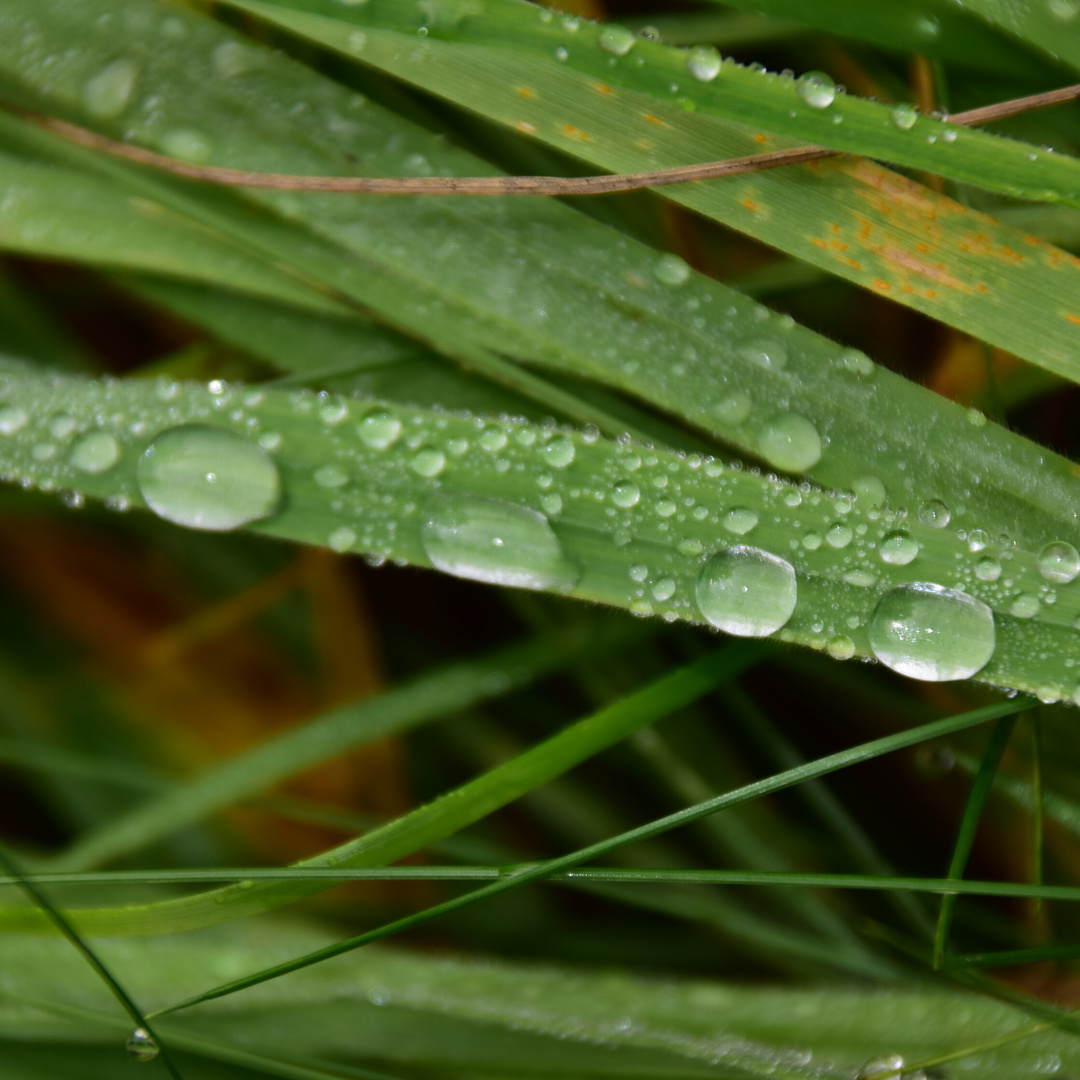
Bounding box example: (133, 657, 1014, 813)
(138, 424, 281, 532)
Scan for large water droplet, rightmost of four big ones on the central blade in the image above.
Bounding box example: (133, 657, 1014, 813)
(869, 582, 995, 683)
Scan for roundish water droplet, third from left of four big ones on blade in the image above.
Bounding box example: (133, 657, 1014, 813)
(694, 546, 798, 637)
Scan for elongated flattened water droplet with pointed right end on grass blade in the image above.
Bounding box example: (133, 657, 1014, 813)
(420, 496, 578, 589)
